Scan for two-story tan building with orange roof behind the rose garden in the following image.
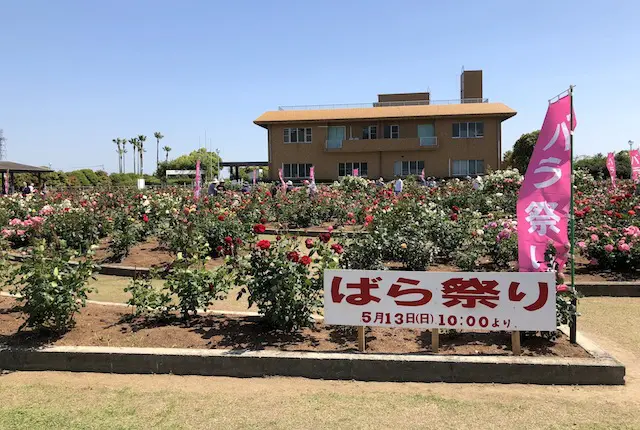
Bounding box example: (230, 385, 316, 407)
(254, 70, 516, 180)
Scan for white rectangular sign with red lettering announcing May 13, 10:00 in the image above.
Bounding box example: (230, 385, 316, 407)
(324, 270, 556, 331)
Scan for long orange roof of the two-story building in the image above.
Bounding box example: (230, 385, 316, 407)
(254, 103, 516, 126)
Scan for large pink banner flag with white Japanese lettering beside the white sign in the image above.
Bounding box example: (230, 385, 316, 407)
(517, 96, 576, 272)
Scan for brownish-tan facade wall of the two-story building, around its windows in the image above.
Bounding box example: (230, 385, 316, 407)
(268, 117, 502, 180)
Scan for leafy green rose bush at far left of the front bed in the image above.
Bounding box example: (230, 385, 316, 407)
(4, 241, 96, 332)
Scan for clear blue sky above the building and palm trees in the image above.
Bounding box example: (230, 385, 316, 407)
(0, 0, 640, 172)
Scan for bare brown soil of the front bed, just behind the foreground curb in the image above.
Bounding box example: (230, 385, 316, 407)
(0, 297, 589, 357)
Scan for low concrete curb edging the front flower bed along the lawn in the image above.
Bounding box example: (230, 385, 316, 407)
(0, 335, 625, 385)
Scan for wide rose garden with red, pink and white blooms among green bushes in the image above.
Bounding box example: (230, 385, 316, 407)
(0, 170, 640, 370)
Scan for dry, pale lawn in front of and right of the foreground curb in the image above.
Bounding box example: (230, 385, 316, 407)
(0, 298, 640, 429)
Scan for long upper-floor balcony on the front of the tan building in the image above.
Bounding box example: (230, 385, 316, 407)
(324, 136, 438, 153)
